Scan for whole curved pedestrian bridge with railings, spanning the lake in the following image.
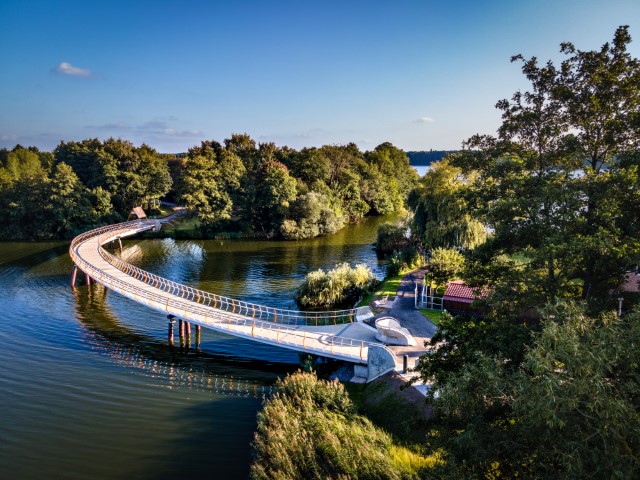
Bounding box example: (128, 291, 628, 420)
(69, 220, 396, 380)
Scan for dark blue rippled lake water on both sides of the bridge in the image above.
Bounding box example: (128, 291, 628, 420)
(0, 218, 392, 479)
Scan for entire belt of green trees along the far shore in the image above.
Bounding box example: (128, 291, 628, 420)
(0, 134, 418, 240)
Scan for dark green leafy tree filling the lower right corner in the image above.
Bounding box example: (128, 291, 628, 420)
(419, 302, 640, 479)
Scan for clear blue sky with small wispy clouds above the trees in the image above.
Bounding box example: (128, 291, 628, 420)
(0, 0, 640, 153)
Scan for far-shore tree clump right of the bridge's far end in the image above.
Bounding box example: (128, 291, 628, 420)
(178, 135, 418, 240)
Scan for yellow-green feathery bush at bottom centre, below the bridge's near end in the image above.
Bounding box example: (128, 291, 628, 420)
(251, 373, 433, 480)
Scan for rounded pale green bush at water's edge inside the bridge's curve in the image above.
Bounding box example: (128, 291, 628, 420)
(296, 263, 378, 308)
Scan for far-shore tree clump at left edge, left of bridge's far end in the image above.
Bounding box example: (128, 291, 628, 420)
(0, 139, 171, 240)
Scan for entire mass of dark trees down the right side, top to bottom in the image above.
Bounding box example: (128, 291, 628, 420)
(412, 27, 640, 479)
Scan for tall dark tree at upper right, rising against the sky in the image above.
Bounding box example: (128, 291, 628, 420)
(453, 27, 640, 308)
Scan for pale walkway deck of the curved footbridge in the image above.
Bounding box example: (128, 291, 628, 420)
(70, 221, 390, 364)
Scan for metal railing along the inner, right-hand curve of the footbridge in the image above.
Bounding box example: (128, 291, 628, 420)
(71, 220, 366, 326)
